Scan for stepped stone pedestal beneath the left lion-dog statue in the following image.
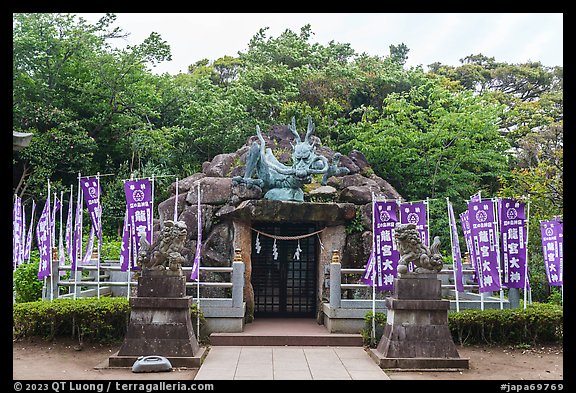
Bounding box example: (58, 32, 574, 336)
(108, 270, 205, 368)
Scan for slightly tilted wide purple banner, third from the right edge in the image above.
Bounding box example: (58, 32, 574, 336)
(468, 199, 501, 292)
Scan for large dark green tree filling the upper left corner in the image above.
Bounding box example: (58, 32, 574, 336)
(13, 13, 170, 231)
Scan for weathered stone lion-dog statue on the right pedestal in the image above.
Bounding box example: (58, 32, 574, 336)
(394, 224, 443, 274)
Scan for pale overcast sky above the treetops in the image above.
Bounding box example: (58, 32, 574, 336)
(76, 13, 564, 75)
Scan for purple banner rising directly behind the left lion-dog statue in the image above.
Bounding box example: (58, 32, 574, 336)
(124, 179, 152, 270)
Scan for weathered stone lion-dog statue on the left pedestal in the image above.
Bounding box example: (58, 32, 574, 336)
(136, 220, 187, 271)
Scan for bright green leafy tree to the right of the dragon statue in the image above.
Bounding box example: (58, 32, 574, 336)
(342, 70, 509, 205)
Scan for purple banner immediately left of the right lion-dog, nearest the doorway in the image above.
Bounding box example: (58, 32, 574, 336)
(361, 201, 400, 291)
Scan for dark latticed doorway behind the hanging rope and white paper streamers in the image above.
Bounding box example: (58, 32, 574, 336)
(252, 224, 318, 318)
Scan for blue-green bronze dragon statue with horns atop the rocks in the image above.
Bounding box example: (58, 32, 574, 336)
(232, 118, 349, 202)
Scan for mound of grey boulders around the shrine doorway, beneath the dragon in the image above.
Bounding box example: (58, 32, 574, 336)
(158, 125, 401, 321)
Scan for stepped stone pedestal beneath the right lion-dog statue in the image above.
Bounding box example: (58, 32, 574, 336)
(370, 273, 469, 369)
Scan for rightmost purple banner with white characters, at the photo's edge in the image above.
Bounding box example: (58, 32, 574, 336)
(540, 218, 564, 286)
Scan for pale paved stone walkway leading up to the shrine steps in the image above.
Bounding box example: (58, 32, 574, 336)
(194, 346, 390, 380)
